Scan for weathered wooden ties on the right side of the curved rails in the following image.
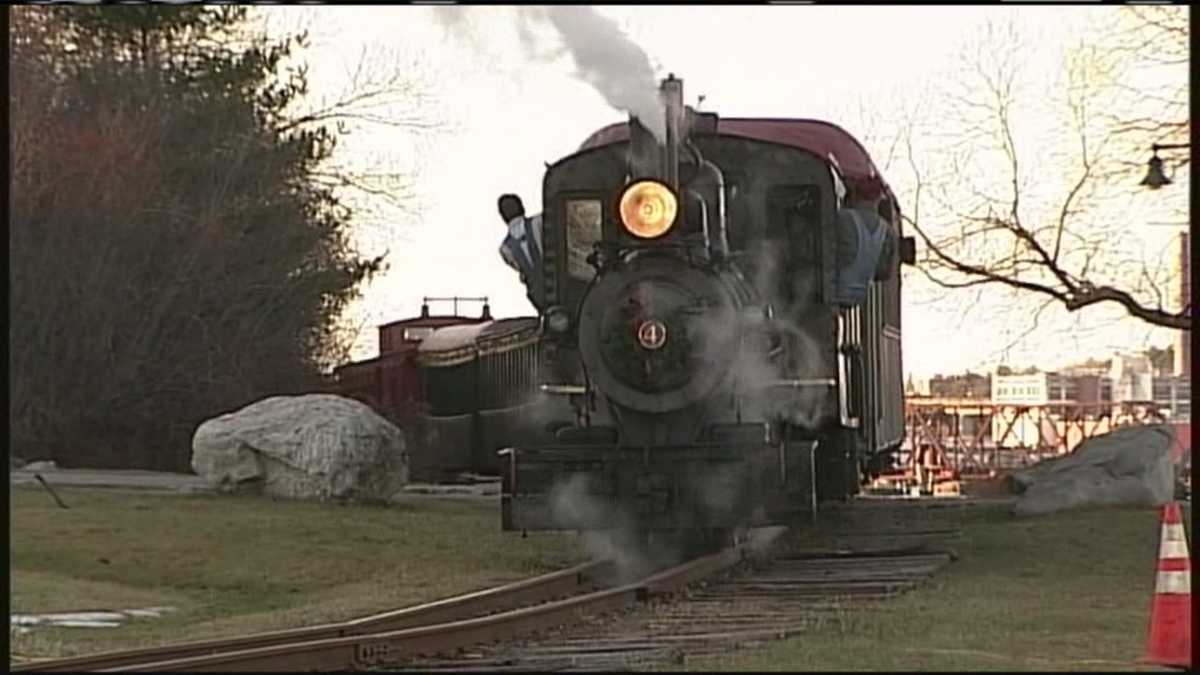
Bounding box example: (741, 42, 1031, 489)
(389, 516, 959, 673)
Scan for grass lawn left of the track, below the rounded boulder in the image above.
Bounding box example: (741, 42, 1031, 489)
(8, 486, 584, 657)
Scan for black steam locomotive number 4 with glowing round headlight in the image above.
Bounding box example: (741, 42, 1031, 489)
(500, 76, 913, 533)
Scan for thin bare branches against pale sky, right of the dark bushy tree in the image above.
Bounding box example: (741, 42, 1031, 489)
(250, 6, 455, 365)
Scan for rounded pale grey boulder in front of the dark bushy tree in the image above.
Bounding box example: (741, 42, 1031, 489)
(192, 394, 408, 501)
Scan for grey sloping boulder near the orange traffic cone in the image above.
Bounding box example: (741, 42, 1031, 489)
(1013, 424, 1175, 515)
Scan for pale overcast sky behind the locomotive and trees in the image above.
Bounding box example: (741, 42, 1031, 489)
(263, 5, 1186, 377)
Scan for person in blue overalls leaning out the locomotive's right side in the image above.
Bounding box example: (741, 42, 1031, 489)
(836, 178, 896, 306)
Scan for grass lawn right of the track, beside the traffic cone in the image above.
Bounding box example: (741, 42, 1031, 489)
(688, 502, 1192, 673)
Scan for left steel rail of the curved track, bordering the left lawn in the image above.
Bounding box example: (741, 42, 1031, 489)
(11, 561, 613, 673)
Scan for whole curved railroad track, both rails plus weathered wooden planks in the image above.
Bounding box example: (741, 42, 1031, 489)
(12, 497, 970, 673)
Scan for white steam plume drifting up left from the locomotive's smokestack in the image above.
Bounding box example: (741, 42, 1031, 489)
(433, 5, 666, 143)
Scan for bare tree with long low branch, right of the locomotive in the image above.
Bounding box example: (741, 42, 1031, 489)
(899, 7, 1192, 329)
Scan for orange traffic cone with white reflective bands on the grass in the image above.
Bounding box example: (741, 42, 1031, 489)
(1146, 502, 1192, 668)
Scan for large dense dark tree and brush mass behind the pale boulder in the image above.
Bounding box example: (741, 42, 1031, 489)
(8, 7, 441, 470)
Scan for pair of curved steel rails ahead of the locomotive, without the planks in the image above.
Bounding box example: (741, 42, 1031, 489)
(12, 528, 781, 673)
